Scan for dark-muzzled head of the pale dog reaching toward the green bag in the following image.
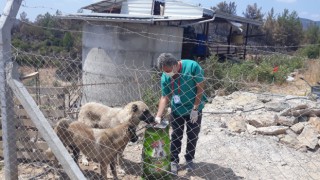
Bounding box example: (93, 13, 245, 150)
(127, 101, 154, 124)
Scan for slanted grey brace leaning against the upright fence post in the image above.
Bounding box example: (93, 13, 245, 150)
(6, 63, 86, 179)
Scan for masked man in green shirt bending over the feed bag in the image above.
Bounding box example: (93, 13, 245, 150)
(155, 53, 207, 174)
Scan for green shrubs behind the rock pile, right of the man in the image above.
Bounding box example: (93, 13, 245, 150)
(202, 55, 304, 94)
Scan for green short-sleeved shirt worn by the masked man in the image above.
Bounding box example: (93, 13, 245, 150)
(161, 59, 207, 116)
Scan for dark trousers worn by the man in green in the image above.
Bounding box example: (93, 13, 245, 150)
(170, 112, 202, 163)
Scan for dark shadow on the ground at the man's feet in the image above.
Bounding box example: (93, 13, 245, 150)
(174, 162, 243, 180)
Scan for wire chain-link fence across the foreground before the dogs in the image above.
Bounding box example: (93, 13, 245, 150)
(1, 21, 320, 179)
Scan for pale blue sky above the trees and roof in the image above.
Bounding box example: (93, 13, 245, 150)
(0, 0, 320, 21)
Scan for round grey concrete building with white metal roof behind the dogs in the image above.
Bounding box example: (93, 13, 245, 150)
(63, 0, 262, 105)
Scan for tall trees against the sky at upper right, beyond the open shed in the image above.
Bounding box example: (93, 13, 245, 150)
(211, 1, 320, 58)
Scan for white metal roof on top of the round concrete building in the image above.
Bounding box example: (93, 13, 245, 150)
(75, 0, 262, 26)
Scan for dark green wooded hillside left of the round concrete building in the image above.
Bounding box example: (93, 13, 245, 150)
(12, 11, 82, 58)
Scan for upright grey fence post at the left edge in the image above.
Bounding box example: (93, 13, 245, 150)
(0, 0, 22, 180)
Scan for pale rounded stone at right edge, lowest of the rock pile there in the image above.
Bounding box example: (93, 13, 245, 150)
(297, 125, 318, 149)
